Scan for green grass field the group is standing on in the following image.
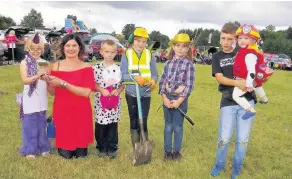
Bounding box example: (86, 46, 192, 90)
(0, 64, 292, 179)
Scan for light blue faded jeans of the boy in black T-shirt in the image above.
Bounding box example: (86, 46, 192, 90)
(215, 100, 254, 169)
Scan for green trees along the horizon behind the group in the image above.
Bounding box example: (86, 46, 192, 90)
(0, 9, 292, 57)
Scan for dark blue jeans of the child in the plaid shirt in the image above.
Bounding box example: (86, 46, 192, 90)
(163, 97, 187, 152)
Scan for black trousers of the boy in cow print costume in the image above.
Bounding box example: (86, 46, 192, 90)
(95, 122, 119, 153)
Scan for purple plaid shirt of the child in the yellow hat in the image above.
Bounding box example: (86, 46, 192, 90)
(159, 57, 195, 97)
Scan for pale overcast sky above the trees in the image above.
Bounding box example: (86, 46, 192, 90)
(0, 1, 292, 37)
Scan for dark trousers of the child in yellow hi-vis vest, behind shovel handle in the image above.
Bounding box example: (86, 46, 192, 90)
(126, 93, 150, 132)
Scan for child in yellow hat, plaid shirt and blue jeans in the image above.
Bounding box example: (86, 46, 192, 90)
(159, 34, 195, 161)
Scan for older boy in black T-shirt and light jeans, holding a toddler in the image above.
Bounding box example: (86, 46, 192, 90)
(211, 23, 256, 179)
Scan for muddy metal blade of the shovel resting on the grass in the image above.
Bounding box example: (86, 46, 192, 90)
(133, 140, 154, 166)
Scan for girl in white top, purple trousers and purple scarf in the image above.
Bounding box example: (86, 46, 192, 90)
(19, 34, 51, 158)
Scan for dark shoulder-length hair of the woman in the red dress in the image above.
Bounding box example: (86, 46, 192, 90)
(58, 34, 85, 59)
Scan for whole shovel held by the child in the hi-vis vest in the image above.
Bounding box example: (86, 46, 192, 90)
(130, 75, 153, 166)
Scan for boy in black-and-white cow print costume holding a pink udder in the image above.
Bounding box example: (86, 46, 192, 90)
(93, 40, 124, 159)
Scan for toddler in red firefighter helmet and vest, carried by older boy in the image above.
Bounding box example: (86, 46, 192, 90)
(232, 24, 273, 119)
